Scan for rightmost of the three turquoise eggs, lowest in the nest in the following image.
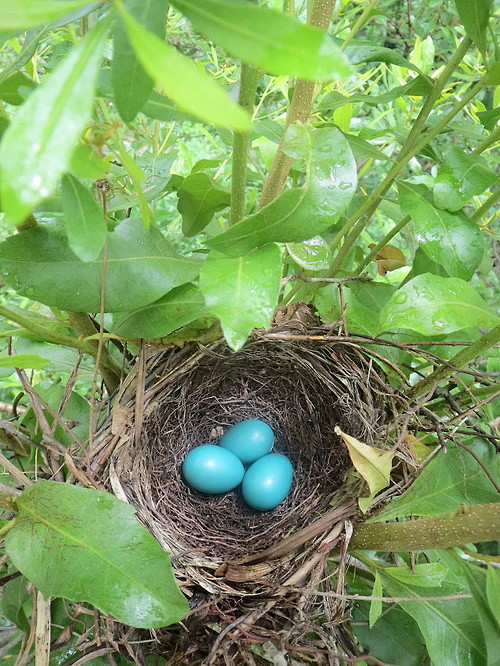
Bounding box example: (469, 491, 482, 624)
(241, 453, 293, 511)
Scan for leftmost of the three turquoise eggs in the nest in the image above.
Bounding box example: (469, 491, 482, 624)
(182, 444, 245, 495)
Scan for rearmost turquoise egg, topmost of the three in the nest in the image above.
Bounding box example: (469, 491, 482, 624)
(219, 419, 274, 465)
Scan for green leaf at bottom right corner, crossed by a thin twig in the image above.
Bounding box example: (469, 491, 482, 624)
(380, 569, 486, 666)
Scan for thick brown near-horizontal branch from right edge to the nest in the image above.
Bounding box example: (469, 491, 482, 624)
(349, 504, 500, 553)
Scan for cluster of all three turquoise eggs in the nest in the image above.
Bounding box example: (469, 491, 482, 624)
(182, 419, 293, 511)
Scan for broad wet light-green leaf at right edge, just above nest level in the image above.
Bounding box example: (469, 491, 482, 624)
(380, 273, 499, 335)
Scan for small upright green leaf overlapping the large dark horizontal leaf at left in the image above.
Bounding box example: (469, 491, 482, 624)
(62, 174, 107, 261)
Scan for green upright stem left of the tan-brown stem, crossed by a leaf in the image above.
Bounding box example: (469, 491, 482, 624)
(231, 63, 260, 224)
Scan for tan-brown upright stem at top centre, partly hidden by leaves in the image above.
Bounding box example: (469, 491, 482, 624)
(259, 0, 335, 208)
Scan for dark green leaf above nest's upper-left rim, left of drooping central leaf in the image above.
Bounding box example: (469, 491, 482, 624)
(112, 284, 207, 340)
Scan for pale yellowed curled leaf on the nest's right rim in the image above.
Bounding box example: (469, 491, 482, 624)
(335, 426, 395, 513)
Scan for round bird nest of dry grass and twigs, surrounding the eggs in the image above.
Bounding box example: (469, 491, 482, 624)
(91, 333, 402, 666)
